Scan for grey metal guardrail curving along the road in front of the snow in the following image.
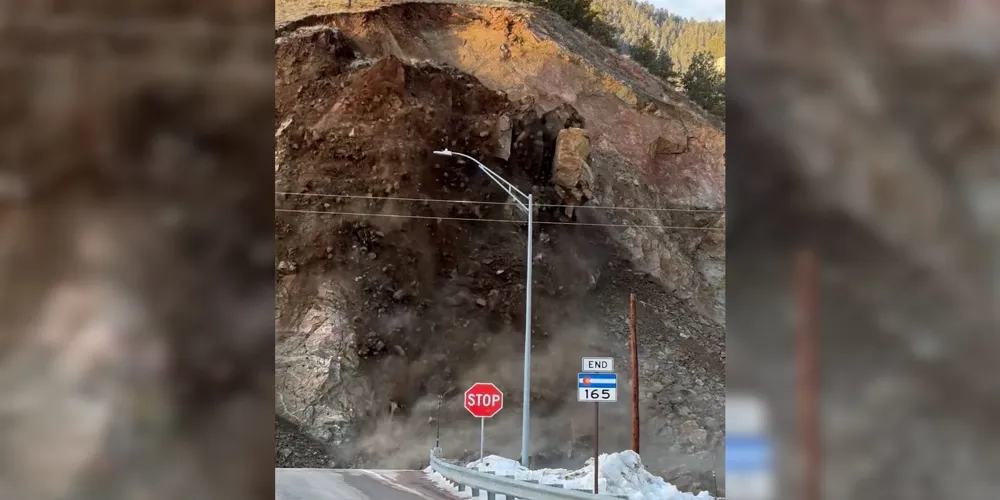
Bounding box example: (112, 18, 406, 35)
(431, 450, 627, 500)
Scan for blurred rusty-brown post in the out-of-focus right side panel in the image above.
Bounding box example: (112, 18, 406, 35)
(795, 249, 822, 500)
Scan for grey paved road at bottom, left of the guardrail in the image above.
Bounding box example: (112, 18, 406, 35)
(274, 469, 457, 500)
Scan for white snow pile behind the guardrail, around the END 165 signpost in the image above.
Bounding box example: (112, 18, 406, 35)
(427, 450, 713, 500)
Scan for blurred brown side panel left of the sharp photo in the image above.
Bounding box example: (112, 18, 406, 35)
(0, 0, 274, 500)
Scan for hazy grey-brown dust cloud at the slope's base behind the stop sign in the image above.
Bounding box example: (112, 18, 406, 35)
(348, 320, 636, 468)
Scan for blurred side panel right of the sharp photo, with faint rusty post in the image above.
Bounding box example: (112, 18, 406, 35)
(727, 0, 1000, 500)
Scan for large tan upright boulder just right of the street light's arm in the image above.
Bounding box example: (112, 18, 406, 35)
(552, 128, 594, 217)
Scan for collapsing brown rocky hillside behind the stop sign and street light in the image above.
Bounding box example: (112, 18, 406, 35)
(275, 3, 725, 488)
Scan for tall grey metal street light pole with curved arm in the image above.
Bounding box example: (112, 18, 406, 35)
(434, 149, 535, 467)
